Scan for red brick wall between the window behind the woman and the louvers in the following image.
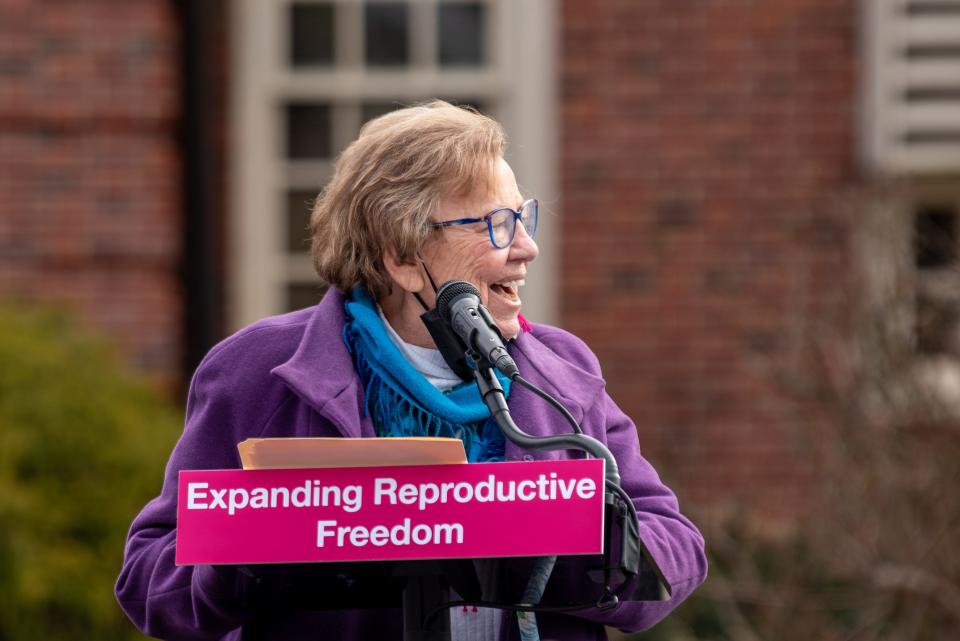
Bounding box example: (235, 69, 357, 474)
(560, 0, 858, 515)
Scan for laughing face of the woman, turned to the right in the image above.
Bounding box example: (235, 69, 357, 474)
(422, 158, 539, 338)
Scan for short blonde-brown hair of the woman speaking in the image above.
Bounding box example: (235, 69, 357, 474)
(310, 100, 506, 299)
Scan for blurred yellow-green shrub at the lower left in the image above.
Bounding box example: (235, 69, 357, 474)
(0, 307, 180, 641)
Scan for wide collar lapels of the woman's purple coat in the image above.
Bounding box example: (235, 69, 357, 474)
(271, 287, 604, 438)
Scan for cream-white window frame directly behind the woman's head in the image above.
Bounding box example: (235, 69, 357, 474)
(227, 0, 560, 329)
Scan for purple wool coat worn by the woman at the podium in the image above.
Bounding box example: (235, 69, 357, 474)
(116, 290, 707, 641)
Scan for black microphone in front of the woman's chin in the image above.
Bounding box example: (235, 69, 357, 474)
(437, 280, 520, 378)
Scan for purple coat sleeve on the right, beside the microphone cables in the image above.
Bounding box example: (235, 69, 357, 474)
(579, 392, 707, 632)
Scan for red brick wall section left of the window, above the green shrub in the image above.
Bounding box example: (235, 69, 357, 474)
(0, 0, 182, 380)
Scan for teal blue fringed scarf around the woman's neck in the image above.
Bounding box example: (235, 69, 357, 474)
(343, 287, 510, 463)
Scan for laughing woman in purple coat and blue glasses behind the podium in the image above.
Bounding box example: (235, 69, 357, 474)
(117, 101, 706, 641)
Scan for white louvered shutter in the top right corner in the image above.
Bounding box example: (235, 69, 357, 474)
(863, 0, 960, 174)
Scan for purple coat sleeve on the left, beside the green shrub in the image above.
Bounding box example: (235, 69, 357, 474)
(116, 358, 256, 640)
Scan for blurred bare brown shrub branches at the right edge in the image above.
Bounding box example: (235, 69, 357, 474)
(640, 185, 960, 641)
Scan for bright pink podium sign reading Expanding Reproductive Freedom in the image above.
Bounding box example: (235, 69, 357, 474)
(176, 459, 604, 565)
